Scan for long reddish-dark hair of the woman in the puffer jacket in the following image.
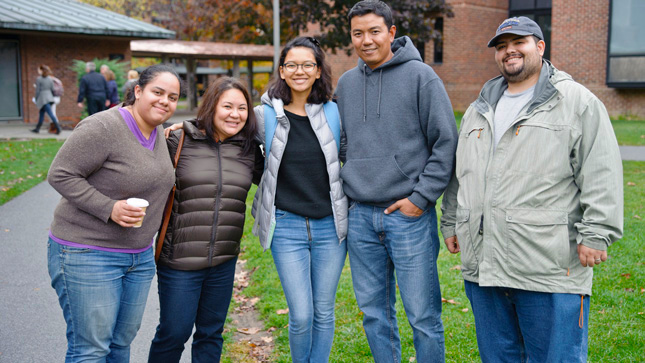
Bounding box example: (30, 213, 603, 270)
(197, 77, 257, 155)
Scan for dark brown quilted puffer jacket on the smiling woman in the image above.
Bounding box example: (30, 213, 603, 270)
(159, 121, 263, 270)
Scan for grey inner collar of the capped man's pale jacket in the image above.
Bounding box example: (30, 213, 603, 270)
(474, 59, 558, 114)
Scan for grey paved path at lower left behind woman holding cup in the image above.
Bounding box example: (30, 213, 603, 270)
(0, 183, 192, 363)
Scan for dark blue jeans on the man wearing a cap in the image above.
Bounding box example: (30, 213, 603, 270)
(465, 281, 589, 363)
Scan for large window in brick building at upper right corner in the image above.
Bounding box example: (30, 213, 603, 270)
(607, 0, 645, 88)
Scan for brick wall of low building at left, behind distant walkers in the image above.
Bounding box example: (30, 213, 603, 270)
(20, 33, 131, 125)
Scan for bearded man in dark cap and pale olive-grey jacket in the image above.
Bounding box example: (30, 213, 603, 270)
(441, 17, 623, 362)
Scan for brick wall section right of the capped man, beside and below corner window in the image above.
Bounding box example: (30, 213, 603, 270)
(551, 0, 645, 117)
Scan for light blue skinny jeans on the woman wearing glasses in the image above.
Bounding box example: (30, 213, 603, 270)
(271, 209, 347, 363)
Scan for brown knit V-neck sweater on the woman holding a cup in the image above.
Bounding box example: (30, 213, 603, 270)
(47, 107, 175, 249)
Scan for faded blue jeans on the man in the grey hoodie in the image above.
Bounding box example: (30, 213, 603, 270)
(347, 201, 445, 363)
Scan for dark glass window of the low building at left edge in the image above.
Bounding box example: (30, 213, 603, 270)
(0, 38, 22, 121)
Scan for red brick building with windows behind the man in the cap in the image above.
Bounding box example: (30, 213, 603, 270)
(330, 0, 645, 118)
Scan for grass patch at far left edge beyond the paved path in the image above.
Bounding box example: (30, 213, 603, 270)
(0, 139, 63, 205)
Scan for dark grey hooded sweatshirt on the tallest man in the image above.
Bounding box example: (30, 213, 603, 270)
(336, 36, 457, 210)
